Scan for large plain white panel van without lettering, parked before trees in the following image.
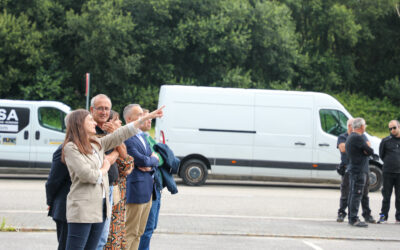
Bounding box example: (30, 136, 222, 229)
(156, 85, 382, 190)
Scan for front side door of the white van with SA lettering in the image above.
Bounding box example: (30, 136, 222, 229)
(31, 106, 66, 168)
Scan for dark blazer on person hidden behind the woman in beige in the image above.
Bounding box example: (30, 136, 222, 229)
(46, 145, 71, 222)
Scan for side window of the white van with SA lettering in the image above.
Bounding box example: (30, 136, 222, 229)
(38, 107, 66, 132)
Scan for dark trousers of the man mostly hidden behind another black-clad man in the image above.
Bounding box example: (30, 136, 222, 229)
(338, 172, 371, 218)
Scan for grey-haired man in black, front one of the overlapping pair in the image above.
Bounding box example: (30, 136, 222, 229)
(345, 118, 374, 227)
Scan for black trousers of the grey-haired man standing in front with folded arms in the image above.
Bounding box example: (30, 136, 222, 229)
(348, 172, 368, 223)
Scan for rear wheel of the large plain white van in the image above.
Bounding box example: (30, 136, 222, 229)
(179, 159, 208, 186)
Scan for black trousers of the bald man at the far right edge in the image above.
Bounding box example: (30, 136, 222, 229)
(381, 172, 400, 221)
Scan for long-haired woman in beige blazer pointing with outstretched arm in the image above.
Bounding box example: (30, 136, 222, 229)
(62, 107, 163, 250)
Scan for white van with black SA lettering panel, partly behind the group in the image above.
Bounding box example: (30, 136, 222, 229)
(0, 99, 70, 174)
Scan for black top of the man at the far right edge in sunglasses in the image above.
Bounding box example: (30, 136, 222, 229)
(379, 135, 400, 173)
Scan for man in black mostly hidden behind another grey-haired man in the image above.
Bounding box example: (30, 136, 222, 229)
(336, 119, 376, 223)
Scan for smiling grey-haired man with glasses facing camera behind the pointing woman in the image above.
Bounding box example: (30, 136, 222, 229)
(90, 94, 119, 249)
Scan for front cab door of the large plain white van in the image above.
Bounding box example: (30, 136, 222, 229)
(313, 108, 348, 179)
